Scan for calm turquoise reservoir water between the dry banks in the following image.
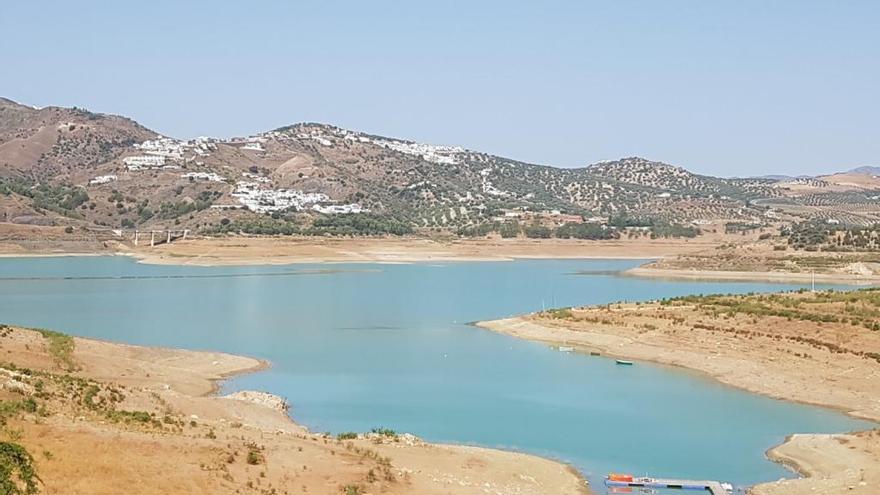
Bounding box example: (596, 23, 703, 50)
(0, 257, 873, 491)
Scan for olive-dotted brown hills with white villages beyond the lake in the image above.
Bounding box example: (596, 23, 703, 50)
(0, 99, 880, 232)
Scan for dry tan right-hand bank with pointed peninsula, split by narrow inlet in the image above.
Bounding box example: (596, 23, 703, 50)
(478, 289, 880, 495)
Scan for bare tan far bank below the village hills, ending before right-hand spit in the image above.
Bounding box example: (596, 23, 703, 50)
(0, 222, 742, 265)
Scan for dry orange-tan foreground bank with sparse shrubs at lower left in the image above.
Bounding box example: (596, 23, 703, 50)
(0, 328, 586, 495)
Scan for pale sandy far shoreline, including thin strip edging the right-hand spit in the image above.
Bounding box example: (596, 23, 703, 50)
(0, 235, 880, 285)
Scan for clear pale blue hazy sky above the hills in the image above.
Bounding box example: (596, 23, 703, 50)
(0, 0, 880, 175)
